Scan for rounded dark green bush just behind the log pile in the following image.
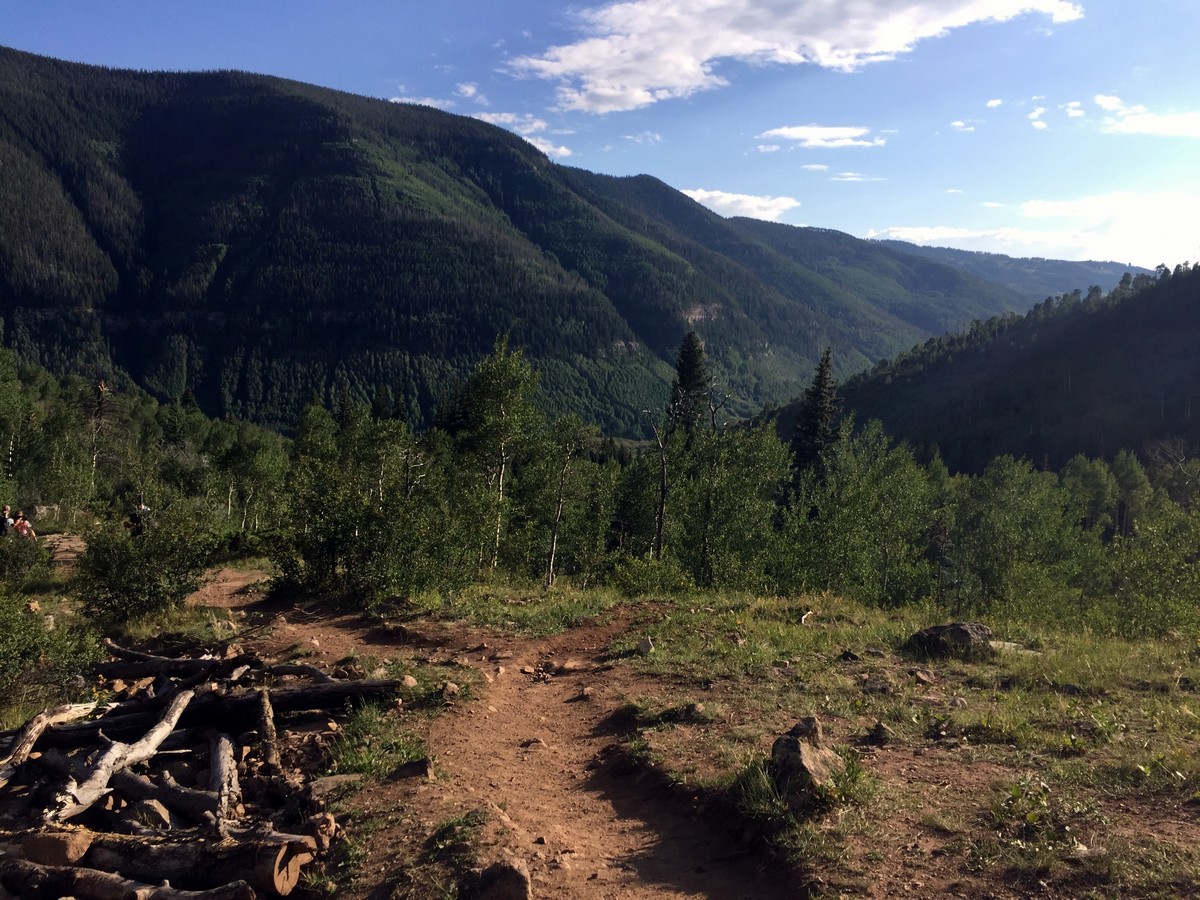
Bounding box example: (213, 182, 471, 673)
(72, 504, 217, 624)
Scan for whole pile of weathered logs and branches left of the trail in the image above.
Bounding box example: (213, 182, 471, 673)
(0, 642, 400, 900)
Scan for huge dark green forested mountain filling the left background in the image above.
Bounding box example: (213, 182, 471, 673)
(0, 49, 1025, 433)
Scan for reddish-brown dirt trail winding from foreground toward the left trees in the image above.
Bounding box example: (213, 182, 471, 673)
(180, 569, 797, 900)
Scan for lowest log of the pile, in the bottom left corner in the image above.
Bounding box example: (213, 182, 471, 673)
(0, 856, 257, 900)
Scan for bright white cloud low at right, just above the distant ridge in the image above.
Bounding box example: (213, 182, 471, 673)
(868, 191, 1200, 269)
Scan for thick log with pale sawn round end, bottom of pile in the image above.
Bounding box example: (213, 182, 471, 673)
(83, 830, 317, 896)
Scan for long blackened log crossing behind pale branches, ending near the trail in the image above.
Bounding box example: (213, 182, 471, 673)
(41, 679, 401, 749)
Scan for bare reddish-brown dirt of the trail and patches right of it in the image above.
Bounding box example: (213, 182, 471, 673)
(171, 569, 1200, 900)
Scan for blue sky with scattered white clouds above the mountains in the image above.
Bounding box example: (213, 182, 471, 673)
(0, 0, 1200, 268)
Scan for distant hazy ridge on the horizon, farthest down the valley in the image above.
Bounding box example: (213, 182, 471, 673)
(878, 240, 1154, 302)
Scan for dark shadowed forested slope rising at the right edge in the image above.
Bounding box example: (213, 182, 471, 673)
(830, 265, 1200, 472)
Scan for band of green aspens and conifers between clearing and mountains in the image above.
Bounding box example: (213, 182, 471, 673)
(7, 272, 1200, 724)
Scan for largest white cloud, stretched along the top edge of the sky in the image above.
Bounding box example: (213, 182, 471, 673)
(510, 0, 1084, 113)
